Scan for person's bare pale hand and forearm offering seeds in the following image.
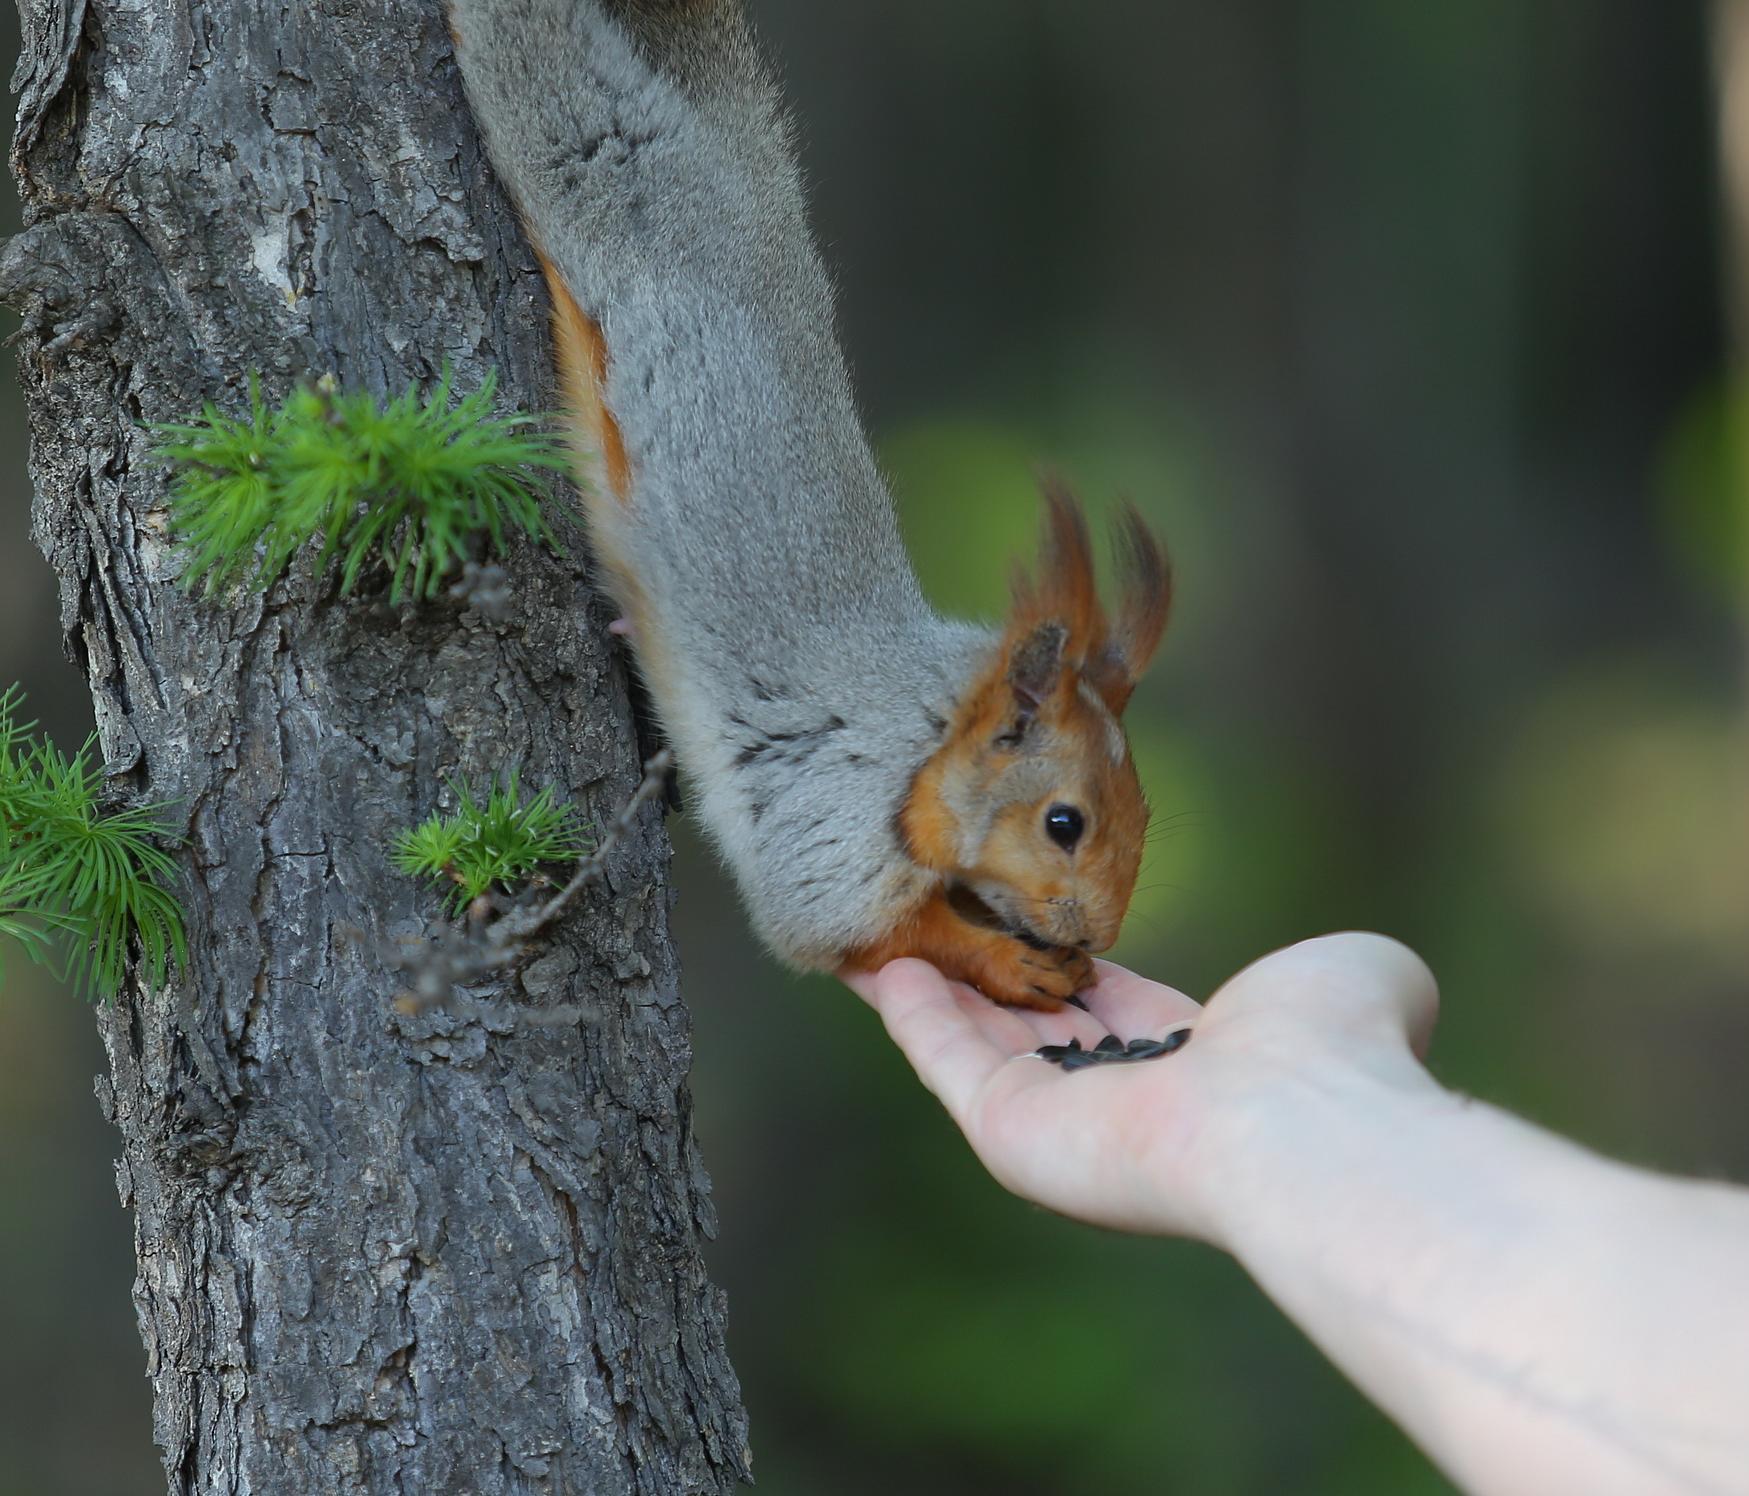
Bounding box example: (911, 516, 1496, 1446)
(845, 934, 1749, 1496)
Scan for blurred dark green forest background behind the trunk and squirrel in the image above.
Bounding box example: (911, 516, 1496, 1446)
(0, 0, 1749, 1496)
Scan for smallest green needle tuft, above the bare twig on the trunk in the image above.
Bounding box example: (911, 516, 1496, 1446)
(390, 773, 588, 919)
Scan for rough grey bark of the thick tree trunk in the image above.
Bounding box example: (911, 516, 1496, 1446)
(0, 0, 747, 1493)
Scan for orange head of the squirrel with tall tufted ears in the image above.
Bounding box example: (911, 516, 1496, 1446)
(899, 481, 1172, 950)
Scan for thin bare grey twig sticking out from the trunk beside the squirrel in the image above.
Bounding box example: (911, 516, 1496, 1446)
(390, 749, 673, 1013)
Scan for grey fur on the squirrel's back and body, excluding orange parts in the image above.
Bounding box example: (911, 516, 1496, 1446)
(449, 0, 999, 969)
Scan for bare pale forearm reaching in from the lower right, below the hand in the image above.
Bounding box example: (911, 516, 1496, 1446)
(1214, 1055, 1749, 1496)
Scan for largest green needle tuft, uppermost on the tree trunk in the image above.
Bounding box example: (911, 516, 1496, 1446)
(150, 369, 567, 604)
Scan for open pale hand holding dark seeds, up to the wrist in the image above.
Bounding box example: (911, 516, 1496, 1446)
(843, 934, 1438, 1244)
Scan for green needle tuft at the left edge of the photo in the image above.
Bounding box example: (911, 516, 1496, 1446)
(0, 686, 187, 999)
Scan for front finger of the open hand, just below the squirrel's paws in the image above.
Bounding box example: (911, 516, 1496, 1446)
(845, 959, 1034, 1122)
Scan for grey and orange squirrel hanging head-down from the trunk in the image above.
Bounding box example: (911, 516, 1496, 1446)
(449, 0, 1172, 1010)
